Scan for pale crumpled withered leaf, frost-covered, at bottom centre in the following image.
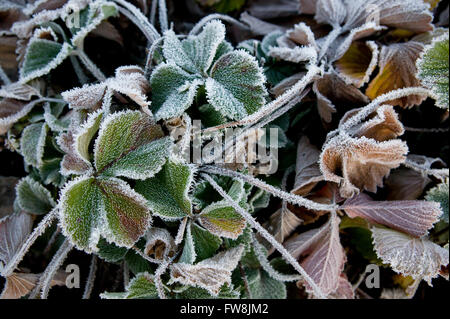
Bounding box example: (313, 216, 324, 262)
(170, 245, 244, 296)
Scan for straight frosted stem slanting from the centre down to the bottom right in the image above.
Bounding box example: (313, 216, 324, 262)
(202, 174, 326, 299)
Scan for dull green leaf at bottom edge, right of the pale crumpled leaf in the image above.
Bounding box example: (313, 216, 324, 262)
(245, 269, 287, 299)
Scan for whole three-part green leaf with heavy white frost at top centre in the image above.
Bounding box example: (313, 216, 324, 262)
(150, 21, 267, 119)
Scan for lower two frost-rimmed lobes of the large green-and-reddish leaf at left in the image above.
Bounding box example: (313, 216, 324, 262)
(59, 176, 151, 252)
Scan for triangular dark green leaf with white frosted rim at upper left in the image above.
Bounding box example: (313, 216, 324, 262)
(20, 38, 72, 83)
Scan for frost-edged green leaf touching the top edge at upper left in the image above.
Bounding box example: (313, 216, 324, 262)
(66, 0, 119, 47)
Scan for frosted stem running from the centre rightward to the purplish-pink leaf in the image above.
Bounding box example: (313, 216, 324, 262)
(199, 165, 338, 211)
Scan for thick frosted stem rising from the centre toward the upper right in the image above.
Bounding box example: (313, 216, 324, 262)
(204, 65, 322, 133)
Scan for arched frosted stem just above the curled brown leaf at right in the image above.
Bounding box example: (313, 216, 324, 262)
(336, 87, 433, 136)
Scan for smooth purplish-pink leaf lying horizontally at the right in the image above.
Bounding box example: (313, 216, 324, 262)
(341, 194, 442, 237)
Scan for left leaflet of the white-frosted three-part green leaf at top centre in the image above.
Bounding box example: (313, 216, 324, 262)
(150, 63, 202, 119)
